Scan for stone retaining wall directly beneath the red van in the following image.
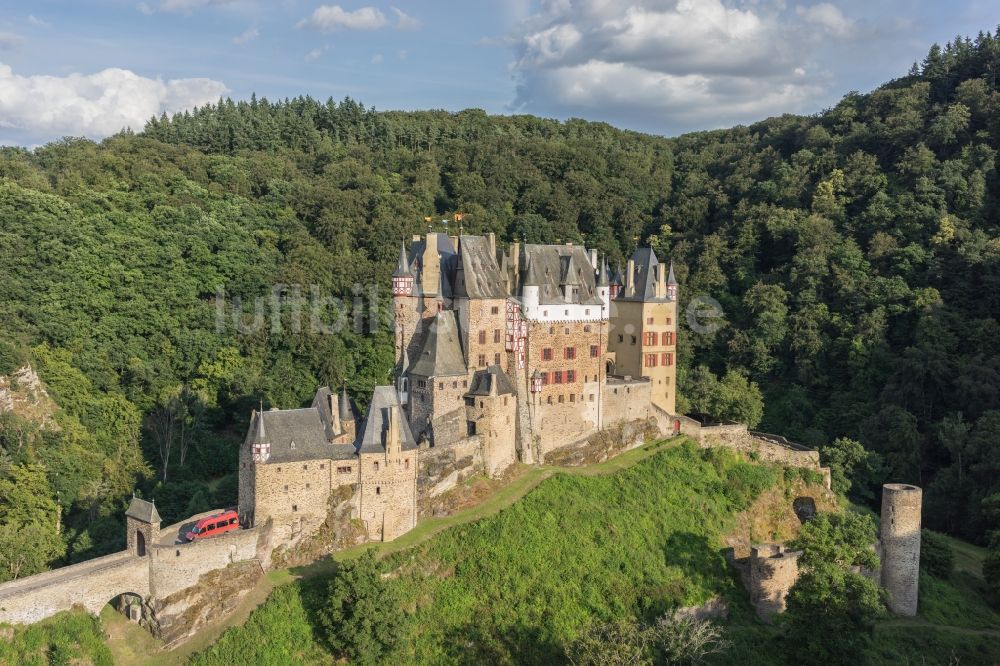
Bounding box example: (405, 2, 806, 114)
(149, 524, 265, 599)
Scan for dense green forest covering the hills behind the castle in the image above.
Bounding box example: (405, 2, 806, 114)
(0, 31, 1000, 580)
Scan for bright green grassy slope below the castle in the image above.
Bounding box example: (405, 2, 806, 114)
(188, 436, 779, 664)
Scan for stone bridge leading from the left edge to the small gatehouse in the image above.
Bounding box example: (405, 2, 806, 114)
(0, 550, 150, 624)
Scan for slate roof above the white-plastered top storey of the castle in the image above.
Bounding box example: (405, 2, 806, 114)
(524, 244, 601, 305)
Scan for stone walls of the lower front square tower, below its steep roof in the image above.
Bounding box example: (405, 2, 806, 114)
(358, 450, 419, 541)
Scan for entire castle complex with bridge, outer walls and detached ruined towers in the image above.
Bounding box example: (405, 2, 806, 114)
(0, 233, 920, 642)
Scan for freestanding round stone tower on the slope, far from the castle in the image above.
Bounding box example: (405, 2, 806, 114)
(879, 483, 923, 617)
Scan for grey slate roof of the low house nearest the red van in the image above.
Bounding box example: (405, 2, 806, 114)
(251, 407, 354, 464)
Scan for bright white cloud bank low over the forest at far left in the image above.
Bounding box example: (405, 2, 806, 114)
(0, 63, 228, 138)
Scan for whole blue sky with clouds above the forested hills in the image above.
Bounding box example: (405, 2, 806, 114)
(0, 0, 1000, 147)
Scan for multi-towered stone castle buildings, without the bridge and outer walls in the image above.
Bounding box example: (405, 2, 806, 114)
(238, 233, 677, 542)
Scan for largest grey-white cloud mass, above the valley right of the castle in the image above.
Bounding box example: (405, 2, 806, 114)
(507, 0, 846, 129)
